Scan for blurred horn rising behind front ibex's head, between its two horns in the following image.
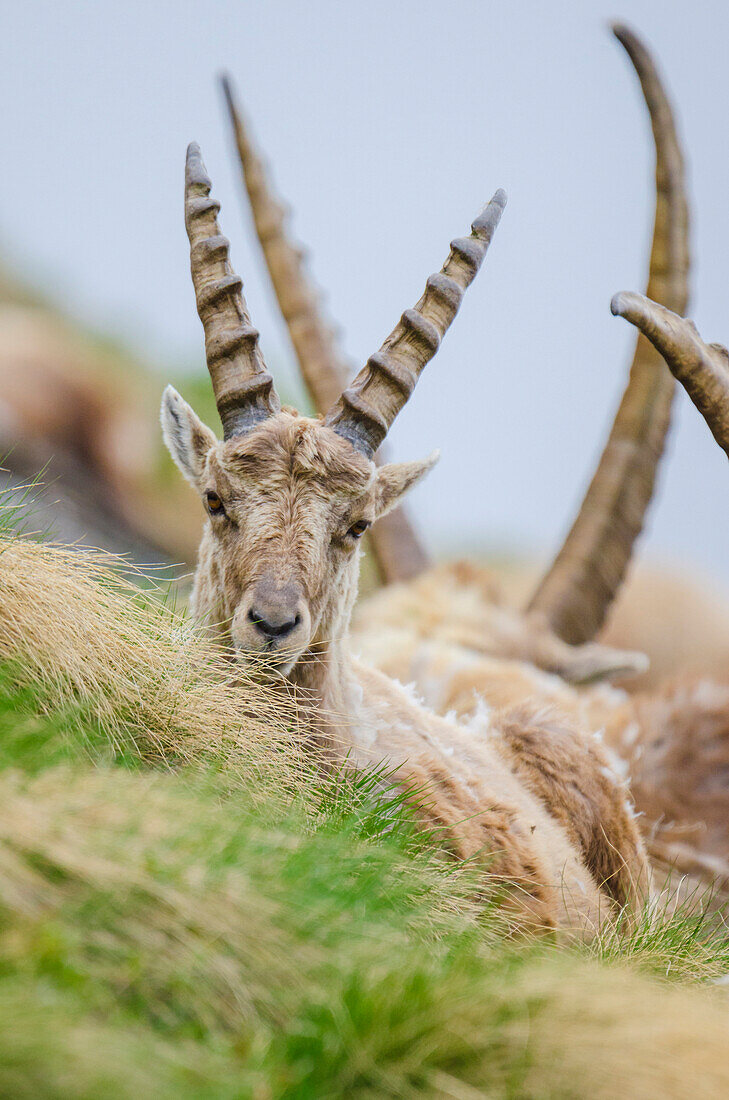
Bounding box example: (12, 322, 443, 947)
(221, 76, 428, 584)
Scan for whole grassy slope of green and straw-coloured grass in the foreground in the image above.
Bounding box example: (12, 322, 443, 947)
(0, 501, 729, 1100)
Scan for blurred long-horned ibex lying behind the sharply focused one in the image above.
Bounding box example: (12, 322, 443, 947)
(225, 26, 729, 893)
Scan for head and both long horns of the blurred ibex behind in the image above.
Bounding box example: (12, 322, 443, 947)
(224, 28, 694, 681)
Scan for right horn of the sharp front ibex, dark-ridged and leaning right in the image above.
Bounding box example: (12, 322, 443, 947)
(324, 189, 506, 458)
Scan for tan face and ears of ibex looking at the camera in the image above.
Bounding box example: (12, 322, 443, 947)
(162, 387, 437, 674)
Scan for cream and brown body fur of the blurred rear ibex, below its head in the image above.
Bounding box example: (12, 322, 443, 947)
(356, 629, 729, 888)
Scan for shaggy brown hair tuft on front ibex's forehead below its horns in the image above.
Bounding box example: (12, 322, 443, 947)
(221, 410, 375, 493)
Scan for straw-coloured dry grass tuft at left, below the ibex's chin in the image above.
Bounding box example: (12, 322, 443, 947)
(0, 537, 306, 798)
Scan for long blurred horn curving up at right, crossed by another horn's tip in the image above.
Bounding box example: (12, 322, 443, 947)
(528, 25, 689, 645)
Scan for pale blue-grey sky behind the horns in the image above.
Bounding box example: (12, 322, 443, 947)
(0, 0, 729, 582)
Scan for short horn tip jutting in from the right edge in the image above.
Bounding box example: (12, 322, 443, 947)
(610, 292, 729, 457)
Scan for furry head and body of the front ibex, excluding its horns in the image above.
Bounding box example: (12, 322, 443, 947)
(163, 400, 649, 933)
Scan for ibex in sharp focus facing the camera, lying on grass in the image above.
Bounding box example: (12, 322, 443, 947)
(162, 145, 649, 932)
